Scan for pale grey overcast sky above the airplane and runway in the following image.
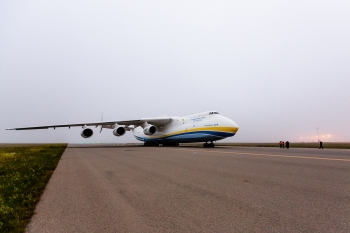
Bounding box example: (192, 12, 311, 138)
(0, 0, 350, 143)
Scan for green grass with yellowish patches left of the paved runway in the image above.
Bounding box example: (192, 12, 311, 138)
(0, 144, 66, 232)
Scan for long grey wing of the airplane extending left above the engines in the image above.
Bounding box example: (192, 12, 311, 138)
(6, 117, 171, 130)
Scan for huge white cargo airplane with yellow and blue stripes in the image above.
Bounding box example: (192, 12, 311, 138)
(6, 111, 239, 147)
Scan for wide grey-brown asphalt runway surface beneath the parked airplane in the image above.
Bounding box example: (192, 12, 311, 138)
(26, 146, 350, 232)
